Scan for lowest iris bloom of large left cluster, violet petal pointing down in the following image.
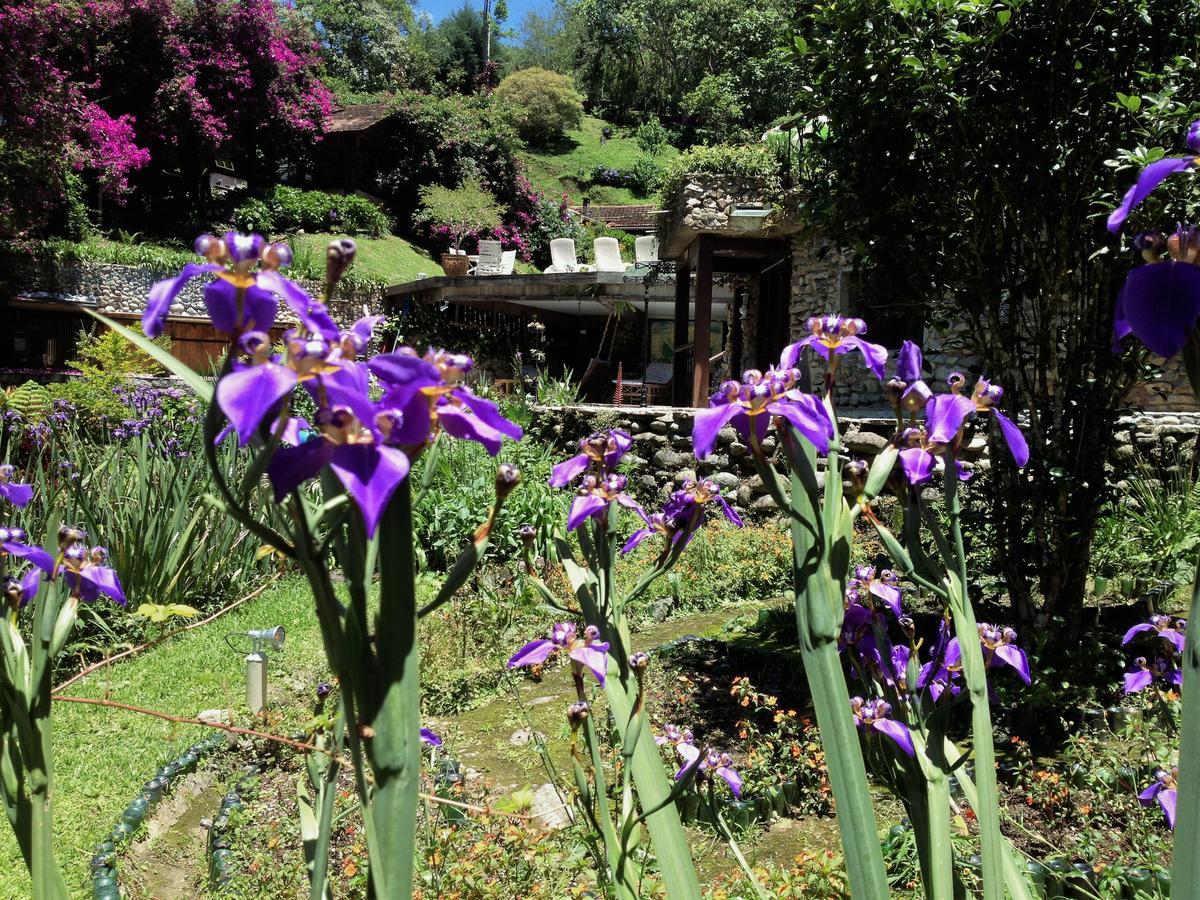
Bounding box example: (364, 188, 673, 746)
(266, 405, 409, 535)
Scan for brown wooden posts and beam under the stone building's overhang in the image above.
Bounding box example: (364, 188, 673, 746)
(667, 233, 791, 407)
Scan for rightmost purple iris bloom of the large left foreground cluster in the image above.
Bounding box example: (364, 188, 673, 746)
(367, 347, 523, 456)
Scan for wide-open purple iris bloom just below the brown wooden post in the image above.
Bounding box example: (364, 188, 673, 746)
(691, 367, 833, 460)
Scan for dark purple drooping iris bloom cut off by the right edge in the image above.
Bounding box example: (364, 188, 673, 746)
(1112, 227, 1200, 359)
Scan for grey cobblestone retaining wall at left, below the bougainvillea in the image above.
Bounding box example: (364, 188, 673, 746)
(8, 262, 383, 324)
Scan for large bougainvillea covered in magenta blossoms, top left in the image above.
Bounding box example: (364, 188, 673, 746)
(0, 0, 332, 236)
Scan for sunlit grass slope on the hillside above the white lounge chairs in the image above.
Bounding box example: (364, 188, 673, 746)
(518, 115, 679, 204)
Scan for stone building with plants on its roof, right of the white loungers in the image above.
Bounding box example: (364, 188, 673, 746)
(659, 173, 1200, 412)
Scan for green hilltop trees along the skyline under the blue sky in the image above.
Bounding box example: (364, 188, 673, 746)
(298, 0, 800, 142)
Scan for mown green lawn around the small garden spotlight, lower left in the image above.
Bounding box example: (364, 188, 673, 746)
(0, 577, 328, 900)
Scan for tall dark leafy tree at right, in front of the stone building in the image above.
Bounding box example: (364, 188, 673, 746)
(790, 0, 1200, 629)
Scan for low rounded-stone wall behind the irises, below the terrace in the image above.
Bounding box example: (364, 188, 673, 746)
(527, 404, 1200, 520)
